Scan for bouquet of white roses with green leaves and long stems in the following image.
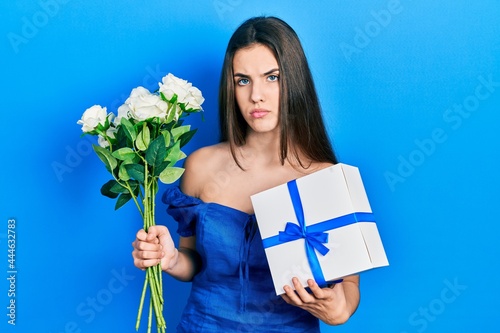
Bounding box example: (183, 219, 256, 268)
(77, 74, 204, 332)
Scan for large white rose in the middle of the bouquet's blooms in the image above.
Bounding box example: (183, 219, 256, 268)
(125, 87, 168, 120)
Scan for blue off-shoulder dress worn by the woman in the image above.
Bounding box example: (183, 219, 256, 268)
(163, 187, 320, 333)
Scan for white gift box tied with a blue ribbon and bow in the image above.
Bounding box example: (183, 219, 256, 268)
(251, 163, 389, 295)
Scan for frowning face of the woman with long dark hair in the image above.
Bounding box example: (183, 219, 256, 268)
(233, 44, 280, 133)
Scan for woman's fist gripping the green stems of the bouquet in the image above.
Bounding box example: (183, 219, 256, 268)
(132, 225, 179, 271)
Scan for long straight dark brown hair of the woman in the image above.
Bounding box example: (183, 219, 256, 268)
(219, 17, 337, 167)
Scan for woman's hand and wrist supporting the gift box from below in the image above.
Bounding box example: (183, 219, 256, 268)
(281, 276, 359, 325)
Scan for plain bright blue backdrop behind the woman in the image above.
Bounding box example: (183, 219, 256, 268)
(0, 0, 500, 333)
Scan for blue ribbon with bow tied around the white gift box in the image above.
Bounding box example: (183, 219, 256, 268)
(262, 180, 375, 286)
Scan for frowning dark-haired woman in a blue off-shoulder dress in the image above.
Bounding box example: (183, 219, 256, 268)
(132, 17, 359, 333)
